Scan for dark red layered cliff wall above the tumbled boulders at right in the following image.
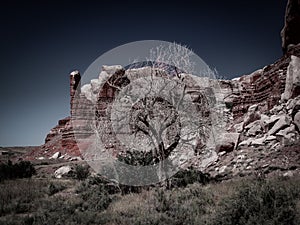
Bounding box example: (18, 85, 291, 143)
(220, 45, 300, 119)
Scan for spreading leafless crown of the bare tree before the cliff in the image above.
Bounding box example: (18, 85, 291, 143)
(110, 43, 210, 165)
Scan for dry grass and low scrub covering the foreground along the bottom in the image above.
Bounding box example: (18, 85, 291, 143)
(0, 173, 300, 225)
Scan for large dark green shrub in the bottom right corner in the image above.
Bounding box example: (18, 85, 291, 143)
(213, 178, 300, 225)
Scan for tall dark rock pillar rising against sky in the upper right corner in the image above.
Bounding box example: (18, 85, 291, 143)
(281, 0, 300, 53)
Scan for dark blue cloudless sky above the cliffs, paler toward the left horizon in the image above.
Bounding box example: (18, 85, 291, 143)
(0, 0, 287, 146)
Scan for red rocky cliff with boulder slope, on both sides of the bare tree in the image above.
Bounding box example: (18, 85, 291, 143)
(28, 0, 300, 178)
